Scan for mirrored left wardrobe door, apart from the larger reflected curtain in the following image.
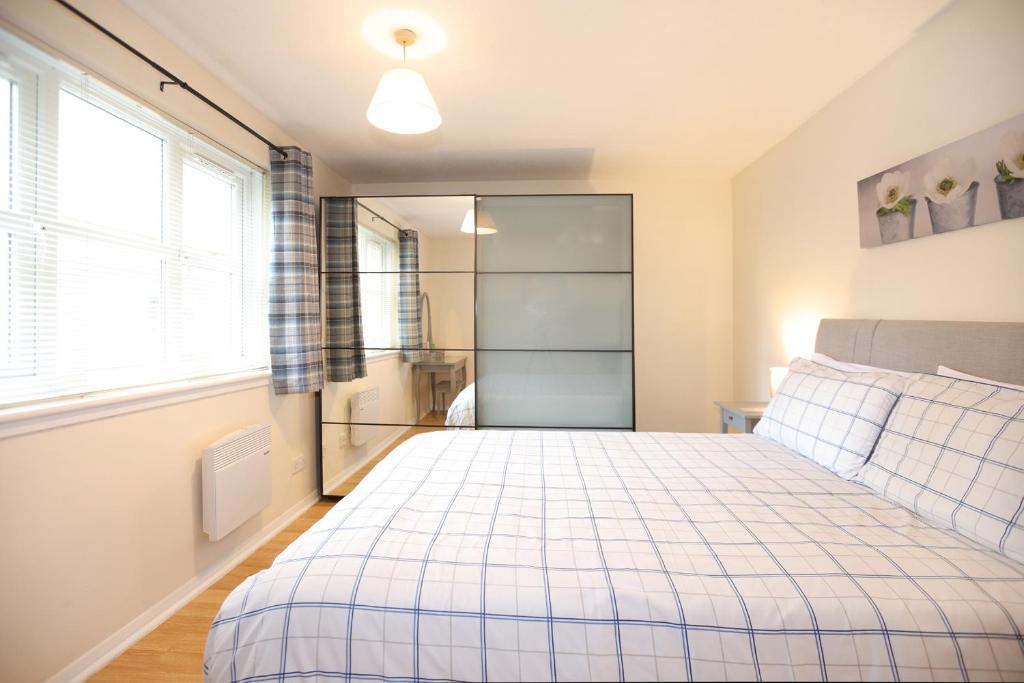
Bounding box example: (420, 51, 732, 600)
(321, 196, 475, 496)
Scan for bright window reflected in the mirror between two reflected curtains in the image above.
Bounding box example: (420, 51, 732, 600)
(359, 225, 398, 349)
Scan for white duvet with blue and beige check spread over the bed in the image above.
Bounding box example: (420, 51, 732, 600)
(204, 430, 1024, 681)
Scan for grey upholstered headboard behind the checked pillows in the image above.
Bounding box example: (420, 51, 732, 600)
(814, 319, 1024, 384)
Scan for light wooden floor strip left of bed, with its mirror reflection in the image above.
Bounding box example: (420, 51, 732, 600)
(90, 413, 444, 683)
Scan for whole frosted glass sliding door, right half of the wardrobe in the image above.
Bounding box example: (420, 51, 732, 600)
(476, 195, 635, 429)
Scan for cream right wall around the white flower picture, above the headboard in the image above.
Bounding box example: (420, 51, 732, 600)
(732, 0, 1024, 399)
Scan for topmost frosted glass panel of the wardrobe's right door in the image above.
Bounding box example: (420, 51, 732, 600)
(476, 195, 633, 272)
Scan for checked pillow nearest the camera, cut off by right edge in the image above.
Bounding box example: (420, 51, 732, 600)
(859, 375, 1024, 561)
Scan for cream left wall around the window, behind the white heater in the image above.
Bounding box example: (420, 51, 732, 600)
(0, 0, 348, 681)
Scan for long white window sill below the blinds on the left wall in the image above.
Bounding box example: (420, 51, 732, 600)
(0, 370, 270, 439)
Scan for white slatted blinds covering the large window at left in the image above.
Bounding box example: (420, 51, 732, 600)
(0, 31, 268, 405)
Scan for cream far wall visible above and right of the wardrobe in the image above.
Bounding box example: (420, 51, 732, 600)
(352, 175, 732, 431)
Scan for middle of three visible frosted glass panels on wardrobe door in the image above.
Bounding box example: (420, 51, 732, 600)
(476, 272, 633, 351)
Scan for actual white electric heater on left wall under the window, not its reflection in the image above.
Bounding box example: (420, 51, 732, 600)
(203, 425, 271, 541)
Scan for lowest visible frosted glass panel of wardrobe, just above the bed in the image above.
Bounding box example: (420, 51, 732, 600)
(476, 351, 633, 429)
